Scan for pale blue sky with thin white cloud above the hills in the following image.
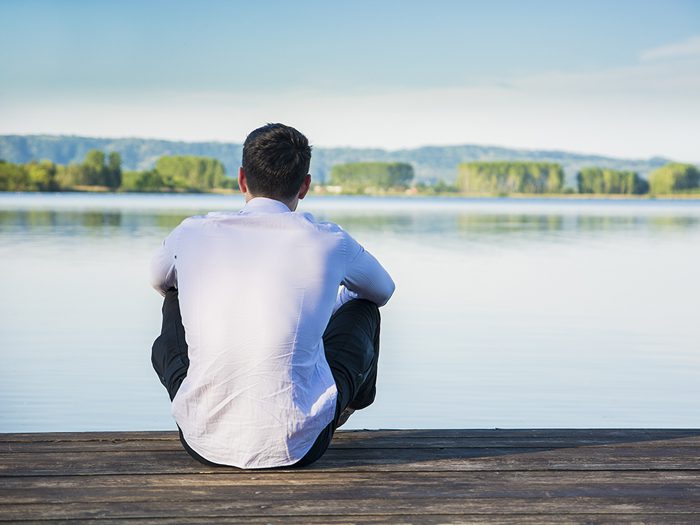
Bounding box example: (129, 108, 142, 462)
(0, 0, 700, 163)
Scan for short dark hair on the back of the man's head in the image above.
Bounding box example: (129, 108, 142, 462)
(243, 124, 311, 200)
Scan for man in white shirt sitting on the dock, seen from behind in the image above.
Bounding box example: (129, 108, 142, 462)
(152, 124, 394, 468)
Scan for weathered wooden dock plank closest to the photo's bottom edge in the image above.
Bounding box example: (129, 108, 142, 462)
(2, 497, 700, 521)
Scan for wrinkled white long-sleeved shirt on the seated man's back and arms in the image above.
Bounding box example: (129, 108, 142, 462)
(151, 197, 394, 468)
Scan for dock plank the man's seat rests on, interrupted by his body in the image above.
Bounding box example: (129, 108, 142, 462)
(0, 444, 700, 476)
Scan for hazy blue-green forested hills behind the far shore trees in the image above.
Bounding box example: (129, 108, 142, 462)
(0, 135, 680, 185)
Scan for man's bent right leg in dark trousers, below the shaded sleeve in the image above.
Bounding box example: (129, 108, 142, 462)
(295, 299, 380, 467)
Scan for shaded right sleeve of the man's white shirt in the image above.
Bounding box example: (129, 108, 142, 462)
(339, 230, 396, 306)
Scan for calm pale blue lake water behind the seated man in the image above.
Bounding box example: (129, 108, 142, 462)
(0, 194, 700, 432)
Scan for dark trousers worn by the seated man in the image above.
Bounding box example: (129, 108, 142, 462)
(151, 288, 380, 467)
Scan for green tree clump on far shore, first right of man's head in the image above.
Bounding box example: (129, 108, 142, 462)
(329, 162, 414, 192)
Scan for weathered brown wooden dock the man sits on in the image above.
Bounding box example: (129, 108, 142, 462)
(0, 429, 700, 524)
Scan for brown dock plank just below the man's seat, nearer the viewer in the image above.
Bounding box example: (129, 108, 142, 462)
(0, 470, 700, 508)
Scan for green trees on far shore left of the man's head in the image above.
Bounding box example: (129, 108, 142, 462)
(0, 150, 237, 192)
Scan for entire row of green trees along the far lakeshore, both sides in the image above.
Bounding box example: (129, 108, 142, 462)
(0, 150, 700, 195)
